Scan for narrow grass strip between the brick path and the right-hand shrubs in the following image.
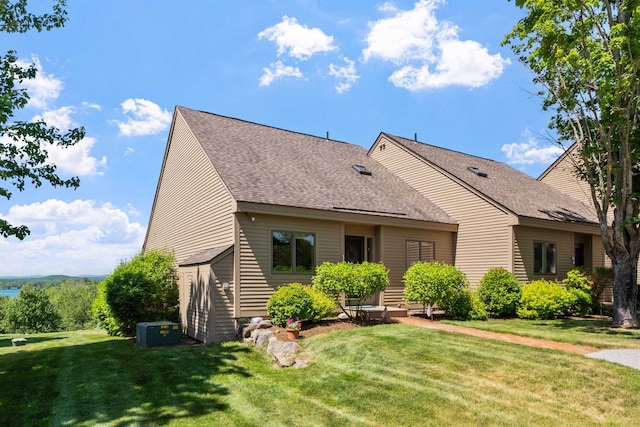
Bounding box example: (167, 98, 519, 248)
(443, 319, 640, 348)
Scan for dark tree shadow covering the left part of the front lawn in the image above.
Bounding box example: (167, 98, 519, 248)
(0, 340, 251, 426)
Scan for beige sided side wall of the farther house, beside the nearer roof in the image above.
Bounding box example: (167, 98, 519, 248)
(371, 139, 511, 285)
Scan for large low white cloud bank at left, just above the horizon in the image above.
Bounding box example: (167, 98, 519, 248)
(0, 199, 146, 275)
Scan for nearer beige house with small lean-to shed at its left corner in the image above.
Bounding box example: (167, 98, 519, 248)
(143, 107, 458, 342)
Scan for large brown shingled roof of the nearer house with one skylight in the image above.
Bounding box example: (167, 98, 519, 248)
(176, 107, 455, 224)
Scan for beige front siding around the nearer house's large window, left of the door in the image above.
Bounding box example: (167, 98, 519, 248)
(236, 213, 343, 317)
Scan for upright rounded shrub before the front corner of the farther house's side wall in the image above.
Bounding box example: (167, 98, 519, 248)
(478, 267, 522, 318)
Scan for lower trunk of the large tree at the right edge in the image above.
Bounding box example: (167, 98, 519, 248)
(613, 258, 639, 328)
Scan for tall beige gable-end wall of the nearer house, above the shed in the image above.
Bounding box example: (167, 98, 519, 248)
(144, 113, 233, 262)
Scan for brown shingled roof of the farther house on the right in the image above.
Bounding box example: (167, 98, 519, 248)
(382, 133, 598, 227)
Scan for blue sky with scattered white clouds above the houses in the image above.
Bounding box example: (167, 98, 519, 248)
(0, 0, 559, 276)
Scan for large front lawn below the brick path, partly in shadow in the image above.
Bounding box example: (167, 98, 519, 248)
(0, 324, 640, 426)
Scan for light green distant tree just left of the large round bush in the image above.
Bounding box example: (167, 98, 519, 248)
(47, 280, 98, 331)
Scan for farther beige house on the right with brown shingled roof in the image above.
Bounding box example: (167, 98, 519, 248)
(369, 133, 603, 286)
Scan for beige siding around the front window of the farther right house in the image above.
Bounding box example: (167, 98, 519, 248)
(513, 226, 574, 282)
